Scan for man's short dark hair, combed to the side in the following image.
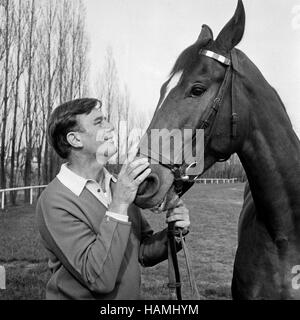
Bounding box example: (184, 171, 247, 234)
(48, 98, 101, 159)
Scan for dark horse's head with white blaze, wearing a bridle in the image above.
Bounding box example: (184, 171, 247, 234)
(135, 0, 245, 209)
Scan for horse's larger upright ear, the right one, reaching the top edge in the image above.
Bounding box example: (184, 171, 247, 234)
(215, 0, 245, 52)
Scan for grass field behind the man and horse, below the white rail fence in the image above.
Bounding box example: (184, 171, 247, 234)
(0, 184, 244, 300)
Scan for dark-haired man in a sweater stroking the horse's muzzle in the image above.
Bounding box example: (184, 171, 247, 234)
(36, 99, 189, 299)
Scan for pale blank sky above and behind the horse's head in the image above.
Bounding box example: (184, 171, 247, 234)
(84, 0, 300, 136)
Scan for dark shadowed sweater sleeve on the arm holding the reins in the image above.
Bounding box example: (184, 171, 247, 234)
(139, 213, 182, 267)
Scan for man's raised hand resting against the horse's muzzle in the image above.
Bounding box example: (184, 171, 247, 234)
(108, 158, 151, 215)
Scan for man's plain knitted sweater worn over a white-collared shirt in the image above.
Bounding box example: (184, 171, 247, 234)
(36, 178, 172, 299)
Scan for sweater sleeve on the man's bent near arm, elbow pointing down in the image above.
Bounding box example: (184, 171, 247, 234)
(37, 197, 131, 293)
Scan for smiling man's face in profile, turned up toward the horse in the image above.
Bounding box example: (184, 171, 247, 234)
(77, 108, 117, 165)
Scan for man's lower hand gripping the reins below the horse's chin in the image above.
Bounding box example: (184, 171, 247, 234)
(166, 199, 190, 234)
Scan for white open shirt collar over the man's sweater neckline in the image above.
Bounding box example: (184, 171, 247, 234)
(56, 163, 117, 197)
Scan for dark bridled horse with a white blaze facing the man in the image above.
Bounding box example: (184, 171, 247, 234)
(135, 0, 300, 300)
